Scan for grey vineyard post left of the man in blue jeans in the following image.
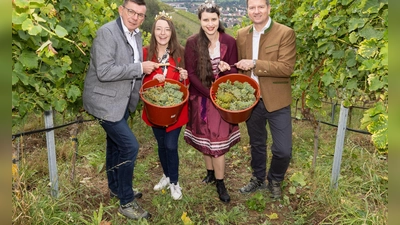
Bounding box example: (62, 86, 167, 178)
(44, 108, 58, 198)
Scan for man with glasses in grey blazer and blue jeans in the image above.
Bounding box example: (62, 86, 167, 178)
(83, 0, 158, 219)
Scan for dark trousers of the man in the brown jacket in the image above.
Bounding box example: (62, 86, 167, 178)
(246, 100, 292, 181)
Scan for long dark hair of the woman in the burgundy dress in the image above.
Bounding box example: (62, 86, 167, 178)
(196, 3, 225, 88)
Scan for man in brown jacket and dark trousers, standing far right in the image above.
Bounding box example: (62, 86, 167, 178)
(236, 0, 296, 198)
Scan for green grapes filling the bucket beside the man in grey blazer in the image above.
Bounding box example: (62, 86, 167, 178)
(142, 82, 183, 106)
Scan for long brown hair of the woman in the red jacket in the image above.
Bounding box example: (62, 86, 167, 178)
(147, 17, 185, 68)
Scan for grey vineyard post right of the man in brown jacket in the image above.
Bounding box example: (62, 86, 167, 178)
(331, 103, 349, 189)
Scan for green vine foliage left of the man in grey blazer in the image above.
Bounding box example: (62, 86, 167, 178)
(12, 0, 117, 122)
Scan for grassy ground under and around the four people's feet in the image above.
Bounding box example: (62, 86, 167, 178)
(12, 105, 388, 225)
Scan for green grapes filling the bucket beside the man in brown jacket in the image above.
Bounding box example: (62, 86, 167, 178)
(215, 80, 256, 111)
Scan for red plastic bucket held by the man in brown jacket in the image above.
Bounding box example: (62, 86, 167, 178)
(210, 73, 260, 124)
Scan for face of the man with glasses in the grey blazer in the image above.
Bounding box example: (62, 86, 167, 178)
(118, 2, 146, 32)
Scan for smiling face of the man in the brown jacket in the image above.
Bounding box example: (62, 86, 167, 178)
(247, 0, 271, 27)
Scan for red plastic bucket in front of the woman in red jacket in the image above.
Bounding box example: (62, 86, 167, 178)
(139, 78, 189, 127)
